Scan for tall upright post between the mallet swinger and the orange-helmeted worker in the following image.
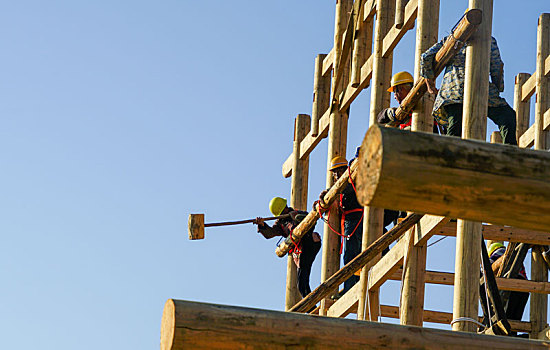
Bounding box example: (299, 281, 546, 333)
(319, 0, 353, 315)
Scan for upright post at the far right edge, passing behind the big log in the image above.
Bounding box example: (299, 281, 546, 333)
(529, 13, 550, 339)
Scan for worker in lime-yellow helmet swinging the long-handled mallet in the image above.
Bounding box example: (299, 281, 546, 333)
(255, 197, 321, 297)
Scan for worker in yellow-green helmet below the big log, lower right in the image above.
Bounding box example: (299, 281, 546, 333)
(480, 241, 529, 321)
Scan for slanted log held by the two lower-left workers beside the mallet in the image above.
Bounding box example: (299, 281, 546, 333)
(275, 161, 358, 258)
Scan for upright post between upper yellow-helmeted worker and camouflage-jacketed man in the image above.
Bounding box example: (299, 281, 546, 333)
(399, 0, 439, 326)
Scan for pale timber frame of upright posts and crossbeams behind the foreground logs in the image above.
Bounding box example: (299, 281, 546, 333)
(168, 0, 550, 349)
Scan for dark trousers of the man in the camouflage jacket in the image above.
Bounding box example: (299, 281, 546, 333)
(443, 103, 518, 145)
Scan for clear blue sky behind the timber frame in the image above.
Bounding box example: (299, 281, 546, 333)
(0, 0, 550, 349)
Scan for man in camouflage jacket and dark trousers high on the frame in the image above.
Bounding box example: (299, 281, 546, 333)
(420, 30, 517, 145)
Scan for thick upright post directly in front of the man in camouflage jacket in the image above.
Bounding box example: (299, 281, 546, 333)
(453, 0, 493, 332)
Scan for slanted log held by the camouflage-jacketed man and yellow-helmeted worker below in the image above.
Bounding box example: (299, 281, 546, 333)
(395, 9, 481, 120)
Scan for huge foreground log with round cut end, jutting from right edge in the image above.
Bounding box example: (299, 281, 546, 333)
(356, 125, 550, 231)
